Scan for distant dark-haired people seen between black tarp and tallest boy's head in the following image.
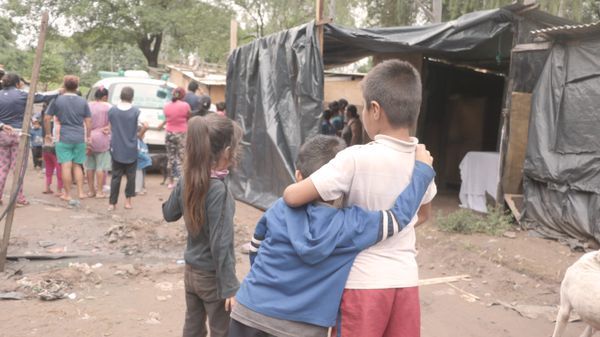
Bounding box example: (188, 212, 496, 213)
(320, 98, 363, 146)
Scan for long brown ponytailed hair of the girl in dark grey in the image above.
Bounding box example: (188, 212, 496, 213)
(183, 114, 242, 236)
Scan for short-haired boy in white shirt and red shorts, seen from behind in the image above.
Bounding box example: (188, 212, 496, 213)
(284, 60, 436, 337)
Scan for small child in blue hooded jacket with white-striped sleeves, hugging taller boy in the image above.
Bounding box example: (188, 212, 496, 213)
(229, 135, 435, 337)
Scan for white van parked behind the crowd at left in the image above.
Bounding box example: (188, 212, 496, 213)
(87, 76, 176, 153)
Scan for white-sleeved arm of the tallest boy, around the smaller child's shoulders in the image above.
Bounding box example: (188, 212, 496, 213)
(283, 148, 356, 207)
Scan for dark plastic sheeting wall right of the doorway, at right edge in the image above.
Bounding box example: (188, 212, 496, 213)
(524, 39, 600, 242)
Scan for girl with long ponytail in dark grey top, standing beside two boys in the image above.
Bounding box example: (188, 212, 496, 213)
(163, 114, 242, 337)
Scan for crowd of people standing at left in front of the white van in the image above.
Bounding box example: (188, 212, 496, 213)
(0, 66, 225, 210)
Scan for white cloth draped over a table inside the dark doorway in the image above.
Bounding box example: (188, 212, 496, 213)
(458, 151, 500, 213)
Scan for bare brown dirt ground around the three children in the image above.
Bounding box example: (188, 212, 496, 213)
(0, 169, 583, 337)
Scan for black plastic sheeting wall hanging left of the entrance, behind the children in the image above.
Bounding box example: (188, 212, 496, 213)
(226, 23, 323, 209)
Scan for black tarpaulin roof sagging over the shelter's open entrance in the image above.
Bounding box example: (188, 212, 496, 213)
(323, 8, 516, 66)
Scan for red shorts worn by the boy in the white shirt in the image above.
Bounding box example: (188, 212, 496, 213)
(332, 287, 421, 337)
